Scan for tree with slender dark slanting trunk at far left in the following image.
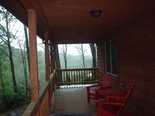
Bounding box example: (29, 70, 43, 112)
(0, 7, 18, 93)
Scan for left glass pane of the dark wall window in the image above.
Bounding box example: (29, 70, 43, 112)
(105, 42, 111, 73)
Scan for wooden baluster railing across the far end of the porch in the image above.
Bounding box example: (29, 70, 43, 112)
(56, 68, 98, 85)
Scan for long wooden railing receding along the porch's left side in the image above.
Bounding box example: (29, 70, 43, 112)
(22, 74, 55, 116)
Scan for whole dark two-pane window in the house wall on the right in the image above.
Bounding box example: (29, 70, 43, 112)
(104, 40, 117, 75)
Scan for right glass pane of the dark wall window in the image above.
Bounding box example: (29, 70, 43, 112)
(111, 41, 117, 74)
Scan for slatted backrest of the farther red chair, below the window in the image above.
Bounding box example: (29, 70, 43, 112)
(101, 74, 112, 88)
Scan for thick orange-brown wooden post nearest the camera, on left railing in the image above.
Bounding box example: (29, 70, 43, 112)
(28, 9, 39, 101)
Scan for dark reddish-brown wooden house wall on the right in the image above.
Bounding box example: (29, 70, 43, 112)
(98, 13, 155, 116)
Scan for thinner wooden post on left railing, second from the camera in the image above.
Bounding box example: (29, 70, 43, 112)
(44, 32, 50, 81)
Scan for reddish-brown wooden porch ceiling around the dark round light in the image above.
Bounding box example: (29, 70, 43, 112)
(0, 0, 155, 43)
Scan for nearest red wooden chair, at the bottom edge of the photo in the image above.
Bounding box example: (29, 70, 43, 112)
(96, 86, 134, 116)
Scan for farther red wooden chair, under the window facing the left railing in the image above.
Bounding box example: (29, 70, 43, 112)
(87, 75, 112, 102)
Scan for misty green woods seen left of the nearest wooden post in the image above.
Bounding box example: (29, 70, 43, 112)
(0, 7, 29, 111)
